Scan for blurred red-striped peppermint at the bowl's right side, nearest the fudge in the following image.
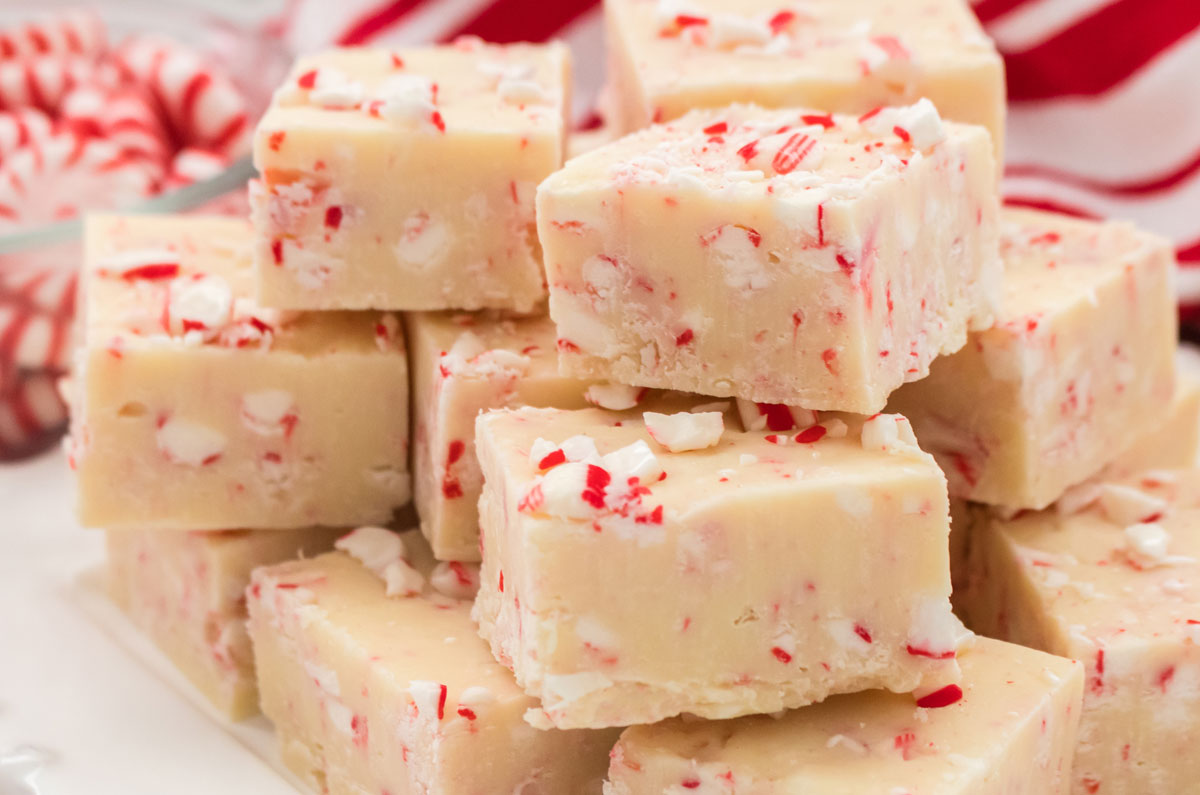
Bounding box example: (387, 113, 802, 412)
(116, 36, 250, 153)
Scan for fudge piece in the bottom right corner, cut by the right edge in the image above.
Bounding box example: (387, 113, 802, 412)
(961, 470, 1200, 795)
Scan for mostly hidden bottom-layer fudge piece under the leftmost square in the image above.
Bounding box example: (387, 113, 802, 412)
(108, 528, 343, 721)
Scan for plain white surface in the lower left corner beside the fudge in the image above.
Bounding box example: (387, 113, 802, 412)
(0, 449, 296, 795)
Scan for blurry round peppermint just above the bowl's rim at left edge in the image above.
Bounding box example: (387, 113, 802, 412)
(0, 131, 162, 228)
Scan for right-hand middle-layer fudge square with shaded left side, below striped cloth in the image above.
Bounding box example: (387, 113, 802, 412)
(888, 209, 1177, 508)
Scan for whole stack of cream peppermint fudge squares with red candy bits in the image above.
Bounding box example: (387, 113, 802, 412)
(67, 0, 1200, 795)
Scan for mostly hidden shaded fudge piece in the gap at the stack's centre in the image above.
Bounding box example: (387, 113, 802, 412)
(404, 312, 600, 561)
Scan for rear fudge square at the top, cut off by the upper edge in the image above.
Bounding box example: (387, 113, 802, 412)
(605, 0, 1004, 151)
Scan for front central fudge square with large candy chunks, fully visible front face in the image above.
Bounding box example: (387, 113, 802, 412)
(475, 406, 961, 728)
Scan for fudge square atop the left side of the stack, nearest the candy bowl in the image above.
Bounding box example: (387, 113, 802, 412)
(251, 40, 569, 311)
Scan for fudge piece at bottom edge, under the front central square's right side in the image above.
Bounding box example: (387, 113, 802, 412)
(605, 639, 1084, 795)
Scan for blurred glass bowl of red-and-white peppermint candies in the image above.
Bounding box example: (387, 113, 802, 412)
(0, 0, 290, 460)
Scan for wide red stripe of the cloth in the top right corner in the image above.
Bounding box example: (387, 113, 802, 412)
(1004, 0, 1200, 102)
